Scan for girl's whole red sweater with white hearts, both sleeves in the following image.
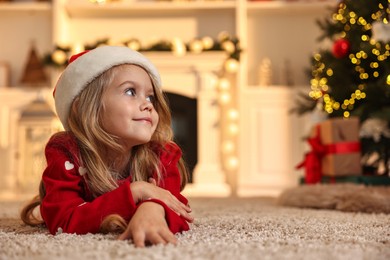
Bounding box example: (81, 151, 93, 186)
(40, 133, 189, 234)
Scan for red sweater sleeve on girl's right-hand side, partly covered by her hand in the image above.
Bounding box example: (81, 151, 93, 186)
(146, 143, 189, 233)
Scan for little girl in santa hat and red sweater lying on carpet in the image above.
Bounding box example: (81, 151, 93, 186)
(21, 46, 193, 247)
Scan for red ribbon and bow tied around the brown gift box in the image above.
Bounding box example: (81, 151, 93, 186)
(296, 125, 360, 184)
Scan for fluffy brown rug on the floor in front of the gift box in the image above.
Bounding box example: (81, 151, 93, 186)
(278, 184, 390, 213)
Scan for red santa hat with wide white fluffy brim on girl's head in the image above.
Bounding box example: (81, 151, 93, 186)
(54, 46, 161, 130)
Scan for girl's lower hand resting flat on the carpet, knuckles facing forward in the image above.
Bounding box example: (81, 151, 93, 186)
(118, 202, 177, 247)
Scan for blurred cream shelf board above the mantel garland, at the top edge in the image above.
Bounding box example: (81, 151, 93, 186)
(65, 1, 236, 17)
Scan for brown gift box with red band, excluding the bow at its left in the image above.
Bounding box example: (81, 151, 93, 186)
(319, 117, 362, 176)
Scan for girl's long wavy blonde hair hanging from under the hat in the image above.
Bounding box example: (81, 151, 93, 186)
(21, 65, 188, 233)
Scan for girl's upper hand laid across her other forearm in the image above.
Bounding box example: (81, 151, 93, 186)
(130, 181, 194, 222)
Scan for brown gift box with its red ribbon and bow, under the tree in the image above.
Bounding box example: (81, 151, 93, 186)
(297, 117, 362, 184)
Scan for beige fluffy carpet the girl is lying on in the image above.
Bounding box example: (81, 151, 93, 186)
(0, 192, 390, 260)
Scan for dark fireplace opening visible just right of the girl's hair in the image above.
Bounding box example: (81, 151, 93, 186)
(165, 92, 198, 183)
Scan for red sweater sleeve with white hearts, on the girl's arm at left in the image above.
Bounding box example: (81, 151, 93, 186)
(40, 135, 136, 234)
